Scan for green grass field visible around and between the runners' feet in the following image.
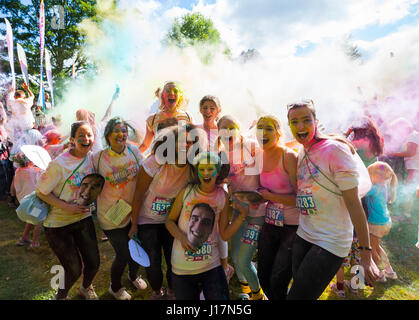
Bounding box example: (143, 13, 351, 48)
(0, 201, 419, 300)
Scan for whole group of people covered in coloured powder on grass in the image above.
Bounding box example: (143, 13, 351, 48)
(0, 82, 419, 300)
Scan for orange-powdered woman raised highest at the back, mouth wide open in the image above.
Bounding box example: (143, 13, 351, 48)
(140, 81, 192, 153)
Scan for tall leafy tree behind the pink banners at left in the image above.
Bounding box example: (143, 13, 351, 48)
(0, 0, 98, 99)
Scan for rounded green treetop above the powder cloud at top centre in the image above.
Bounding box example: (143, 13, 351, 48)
(163, 12, 231, 63)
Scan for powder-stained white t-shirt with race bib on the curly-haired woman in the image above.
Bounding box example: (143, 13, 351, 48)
(138, 155, 192, 224)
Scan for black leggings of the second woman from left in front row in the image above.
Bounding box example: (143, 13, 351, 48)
(103, 223, 140, 292)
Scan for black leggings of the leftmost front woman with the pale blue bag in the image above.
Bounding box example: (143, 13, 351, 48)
(44, 217, 100, 298)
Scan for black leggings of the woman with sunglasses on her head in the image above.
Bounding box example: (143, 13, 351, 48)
(287, 235, 345, 300)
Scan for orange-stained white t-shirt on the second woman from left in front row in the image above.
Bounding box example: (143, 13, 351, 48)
(93, 145, 143, 230)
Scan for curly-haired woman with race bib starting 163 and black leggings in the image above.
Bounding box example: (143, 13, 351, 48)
(129, 125, 204, 300)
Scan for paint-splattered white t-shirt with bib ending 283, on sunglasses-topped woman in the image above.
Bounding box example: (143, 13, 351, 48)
(297, 139, 359, 257)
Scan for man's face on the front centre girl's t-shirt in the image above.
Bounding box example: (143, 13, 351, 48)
(187, 207, 215, 248)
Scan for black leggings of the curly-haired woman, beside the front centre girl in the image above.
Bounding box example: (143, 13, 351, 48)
(138, 224, 173, 291)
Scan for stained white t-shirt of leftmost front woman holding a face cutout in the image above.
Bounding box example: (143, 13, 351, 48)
(36, 151, 94, 228)
